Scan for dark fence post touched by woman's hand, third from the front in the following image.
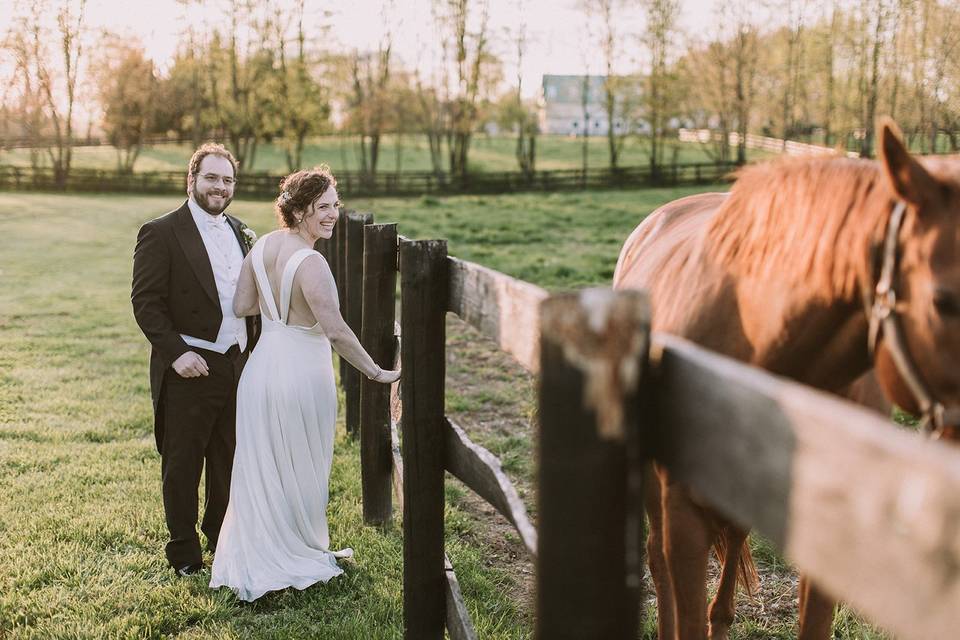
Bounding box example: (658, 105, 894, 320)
(360, 224, 397, 524)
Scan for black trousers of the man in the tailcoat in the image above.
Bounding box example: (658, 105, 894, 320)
(160, 345, 246, 568)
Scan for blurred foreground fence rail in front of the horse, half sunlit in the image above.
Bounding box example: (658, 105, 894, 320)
(651, 335, 960, 640)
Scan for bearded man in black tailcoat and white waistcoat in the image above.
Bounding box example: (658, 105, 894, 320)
(130, 143, 259, 576)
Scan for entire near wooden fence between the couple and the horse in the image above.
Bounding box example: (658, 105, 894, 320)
(321, 208, 960, 640)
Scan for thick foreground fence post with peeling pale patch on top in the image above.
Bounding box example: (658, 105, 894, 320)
(536, 289, 650, 640)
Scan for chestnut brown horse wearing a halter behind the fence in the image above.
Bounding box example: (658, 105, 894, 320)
(614, 121, 960, 640)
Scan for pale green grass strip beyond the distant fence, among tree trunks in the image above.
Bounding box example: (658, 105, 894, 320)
(0, 136, 769, 173)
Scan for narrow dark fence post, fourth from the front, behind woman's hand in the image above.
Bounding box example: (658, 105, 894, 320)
(343, 213, 373, 437)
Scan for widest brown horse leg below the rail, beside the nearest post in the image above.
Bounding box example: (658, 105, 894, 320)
(661, 482, 713, 640)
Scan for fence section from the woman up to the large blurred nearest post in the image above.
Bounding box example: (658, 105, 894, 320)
(318, 212, 546, 639)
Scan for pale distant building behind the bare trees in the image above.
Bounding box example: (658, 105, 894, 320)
(539, 75, 626, 136)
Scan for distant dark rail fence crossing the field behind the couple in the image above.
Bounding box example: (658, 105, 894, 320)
(0, 163, 736, 198)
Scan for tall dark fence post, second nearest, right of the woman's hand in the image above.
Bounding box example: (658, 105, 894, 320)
(400, 240, 448, 640)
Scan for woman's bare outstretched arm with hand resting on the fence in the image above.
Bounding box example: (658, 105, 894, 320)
(300, 256, 400, 382)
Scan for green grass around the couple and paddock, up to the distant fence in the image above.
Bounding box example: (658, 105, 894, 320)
(0, 189, 882, 640)
